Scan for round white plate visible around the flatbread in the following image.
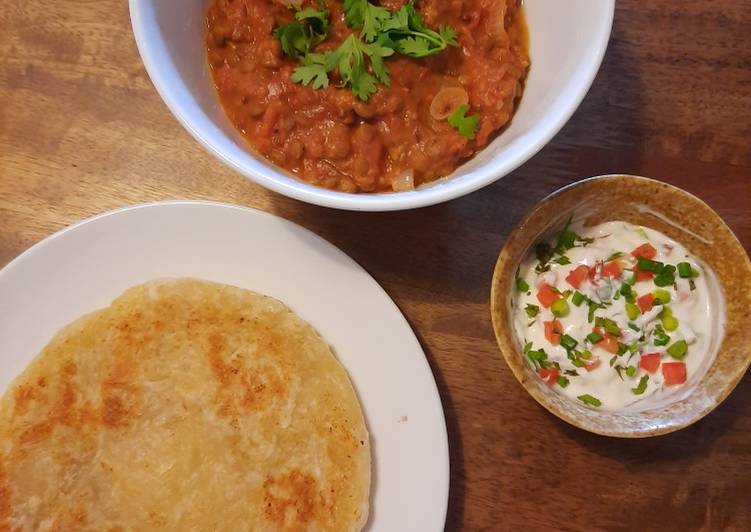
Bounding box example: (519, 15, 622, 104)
(0, 202, 449, 532)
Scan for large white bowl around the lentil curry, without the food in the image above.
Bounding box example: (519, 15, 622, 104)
(130, 0, 615, 211)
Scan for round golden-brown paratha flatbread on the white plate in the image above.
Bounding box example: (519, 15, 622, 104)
(0, 279, 370, 531)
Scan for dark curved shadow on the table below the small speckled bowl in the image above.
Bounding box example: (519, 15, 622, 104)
(546, 375, 751, 462)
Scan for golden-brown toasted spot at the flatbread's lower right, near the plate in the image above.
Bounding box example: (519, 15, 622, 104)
(263, 469, 324, 531)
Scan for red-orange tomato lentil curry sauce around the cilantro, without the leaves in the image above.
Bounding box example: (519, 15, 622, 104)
(207, 0, 529, 192)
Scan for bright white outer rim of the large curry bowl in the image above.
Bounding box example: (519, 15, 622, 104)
(129, 0, 615, 211)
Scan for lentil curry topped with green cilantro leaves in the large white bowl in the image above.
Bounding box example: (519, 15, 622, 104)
(207, 0, 529, 192)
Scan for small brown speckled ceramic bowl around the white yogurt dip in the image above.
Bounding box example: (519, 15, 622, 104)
(490, 175, 751, 438)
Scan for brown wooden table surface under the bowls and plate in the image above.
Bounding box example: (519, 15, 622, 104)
(0, 0, 751, 530)
